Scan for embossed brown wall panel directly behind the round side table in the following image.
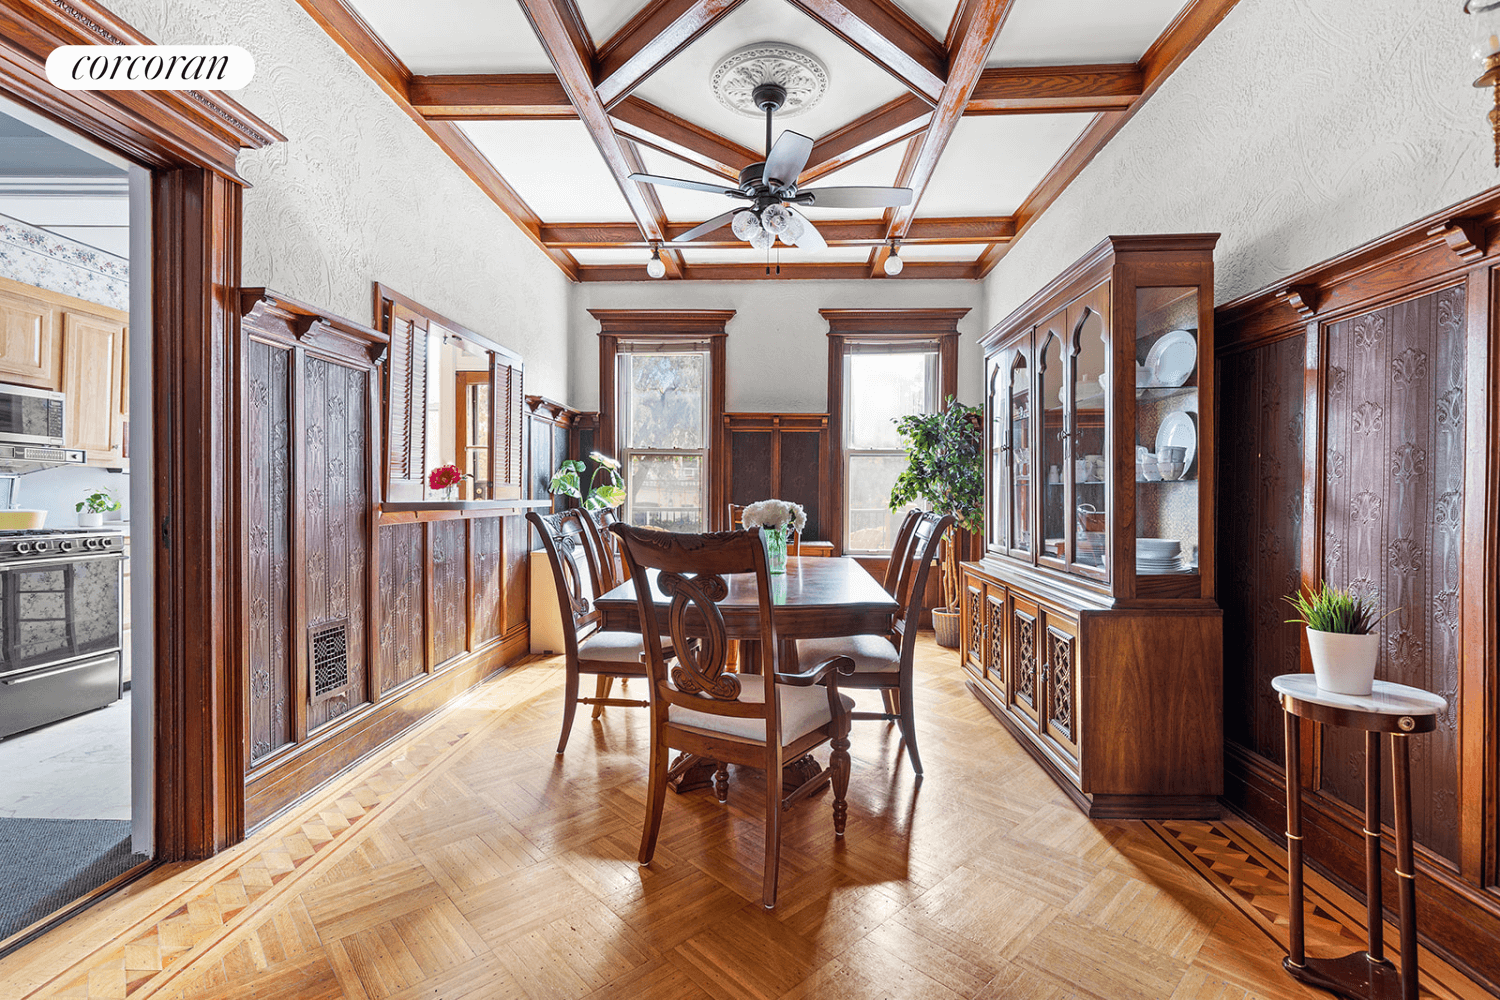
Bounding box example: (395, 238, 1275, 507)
(1322, 286, 1466, 859)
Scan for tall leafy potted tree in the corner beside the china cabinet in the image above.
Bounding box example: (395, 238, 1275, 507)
(891, 396, 984, 649)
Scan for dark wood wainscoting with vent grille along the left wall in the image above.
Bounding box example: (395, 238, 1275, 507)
(239, 288, 530, 828)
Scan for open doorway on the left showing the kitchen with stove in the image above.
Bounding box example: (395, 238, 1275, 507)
(0, 100, 153, 949)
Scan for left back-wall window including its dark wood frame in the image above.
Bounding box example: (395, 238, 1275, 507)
(590, 309, 735, 531)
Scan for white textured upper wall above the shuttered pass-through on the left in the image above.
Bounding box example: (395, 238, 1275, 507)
(108, 0, 570, 397)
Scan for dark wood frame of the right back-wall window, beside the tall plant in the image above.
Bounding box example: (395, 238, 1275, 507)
(818, 309, 969, 556)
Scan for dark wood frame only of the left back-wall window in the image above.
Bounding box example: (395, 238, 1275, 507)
(588, 309, 735, 531)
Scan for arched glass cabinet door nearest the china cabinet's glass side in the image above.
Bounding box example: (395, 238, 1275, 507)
(1067, 301, 1113, 577)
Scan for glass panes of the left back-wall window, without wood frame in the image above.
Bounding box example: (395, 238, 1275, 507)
(617, 351, 710, 531)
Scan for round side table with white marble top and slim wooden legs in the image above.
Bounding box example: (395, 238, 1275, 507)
(1271, 673, 1448, 1000)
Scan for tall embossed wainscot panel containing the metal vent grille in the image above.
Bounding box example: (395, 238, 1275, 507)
(299, 355, 371, 730)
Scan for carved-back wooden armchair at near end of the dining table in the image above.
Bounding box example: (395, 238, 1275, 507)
(611, 525, 855, 910)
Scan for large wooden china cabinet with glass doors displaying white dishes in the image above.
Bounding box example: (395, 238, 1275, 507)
(962, 234, 1223, 817)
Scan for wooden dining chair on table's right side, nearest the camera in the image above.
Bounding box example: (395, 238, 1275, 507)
(797, 513, 953, 774)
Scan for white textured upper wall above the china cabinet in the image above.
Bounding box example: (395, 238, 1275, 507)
(986, 0, 1500, 324)
